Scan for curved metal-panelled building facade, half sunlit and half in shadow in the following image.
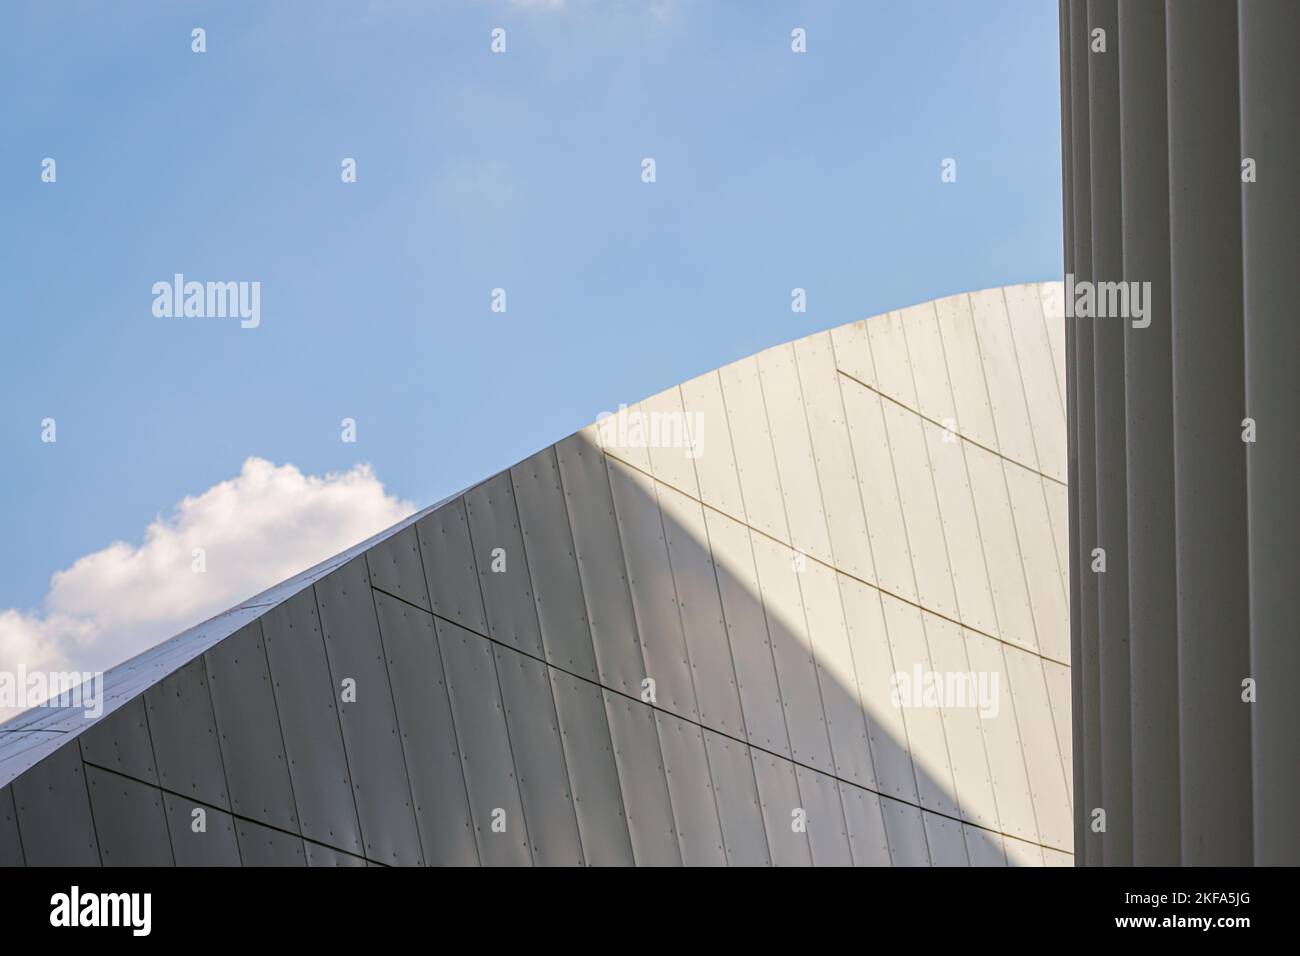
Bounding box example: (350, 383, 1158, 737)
(0, 285, 1074, 866)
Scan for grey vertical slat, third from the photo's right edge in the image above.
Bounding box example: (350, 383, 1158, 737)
(1119, 0, 1179, 866)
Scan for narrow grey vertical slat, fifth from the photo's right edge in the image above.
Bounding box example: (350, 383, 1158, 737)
(1065, 0, 1101, 865)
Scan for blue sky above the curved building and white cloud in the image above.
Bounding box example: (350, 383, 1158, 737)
(0, 0, 1062, 634)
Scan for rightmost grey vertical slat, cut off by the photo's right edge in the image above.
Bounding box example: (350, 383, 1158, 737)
(1239, 0, 1300, 866)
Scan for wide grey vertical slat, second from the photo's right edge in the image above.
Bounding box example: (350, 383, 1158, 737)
(1165, 3, 1253, 866)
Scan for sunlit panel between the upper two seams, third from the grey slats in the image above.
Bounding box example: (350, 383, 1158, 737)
(966, 444, 1037, 650)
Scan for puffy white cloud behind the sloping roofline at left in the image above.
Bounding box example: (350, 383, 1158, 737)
(0, 458, 415, 721)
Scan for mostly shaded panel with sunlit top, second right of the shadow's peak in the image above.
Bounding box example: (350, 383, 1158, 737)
(657, 485, 745, 737)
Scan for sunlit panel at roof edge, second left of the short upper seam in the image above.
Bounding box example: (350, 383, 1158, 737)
(755, 345, 832, 562)
